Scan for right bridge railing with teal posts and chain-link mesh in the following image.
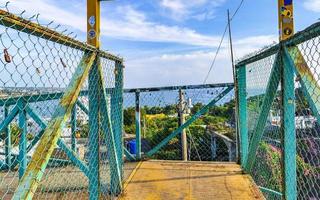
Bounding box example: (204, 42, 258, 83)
(236, 23, 320, 199)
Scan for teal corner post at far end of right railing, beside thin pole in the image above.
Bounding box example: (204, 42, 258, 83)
(237, 66, 249, 167)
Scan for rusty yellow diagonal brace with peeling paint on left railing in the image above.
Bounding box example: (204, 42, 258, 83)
(13, 53, 96, 199)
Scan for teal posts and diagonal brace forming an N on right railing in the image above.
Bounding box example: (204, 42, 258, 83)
(237, 48, 297, 200)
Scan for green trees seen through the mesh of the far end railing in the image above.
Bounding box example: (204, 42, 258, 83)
(124, 101, 234, 160)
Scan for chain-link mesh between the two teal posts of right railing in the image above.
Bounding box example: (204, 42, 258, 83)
(246, 54, 282, 198)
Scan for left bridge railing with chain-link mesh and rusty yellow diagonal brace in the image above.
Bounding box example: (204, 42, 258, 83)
(0, 6, 124, 199)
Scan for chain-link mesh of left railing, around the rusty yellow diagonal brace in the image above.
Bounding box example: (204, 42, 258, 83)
(0, 5, 126, 199)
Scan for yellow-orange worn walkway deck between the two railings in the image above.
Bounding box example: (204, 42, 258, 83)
(120, 161, 264, 200)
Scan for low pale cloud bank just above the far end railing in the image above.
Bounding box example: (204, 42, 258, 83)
(125, 35, 277, 88)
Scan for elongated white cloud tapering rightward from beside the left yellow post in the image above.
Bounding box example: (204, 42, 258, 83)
(102, 6, 219, 47)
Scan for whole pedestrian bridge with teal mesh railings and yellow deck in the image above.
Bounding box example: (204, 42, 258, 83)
(0, 2, 320, 200)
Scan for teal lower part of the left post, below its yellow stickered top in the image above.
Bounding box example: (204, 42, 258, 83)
(89, 59, 100, 200)
